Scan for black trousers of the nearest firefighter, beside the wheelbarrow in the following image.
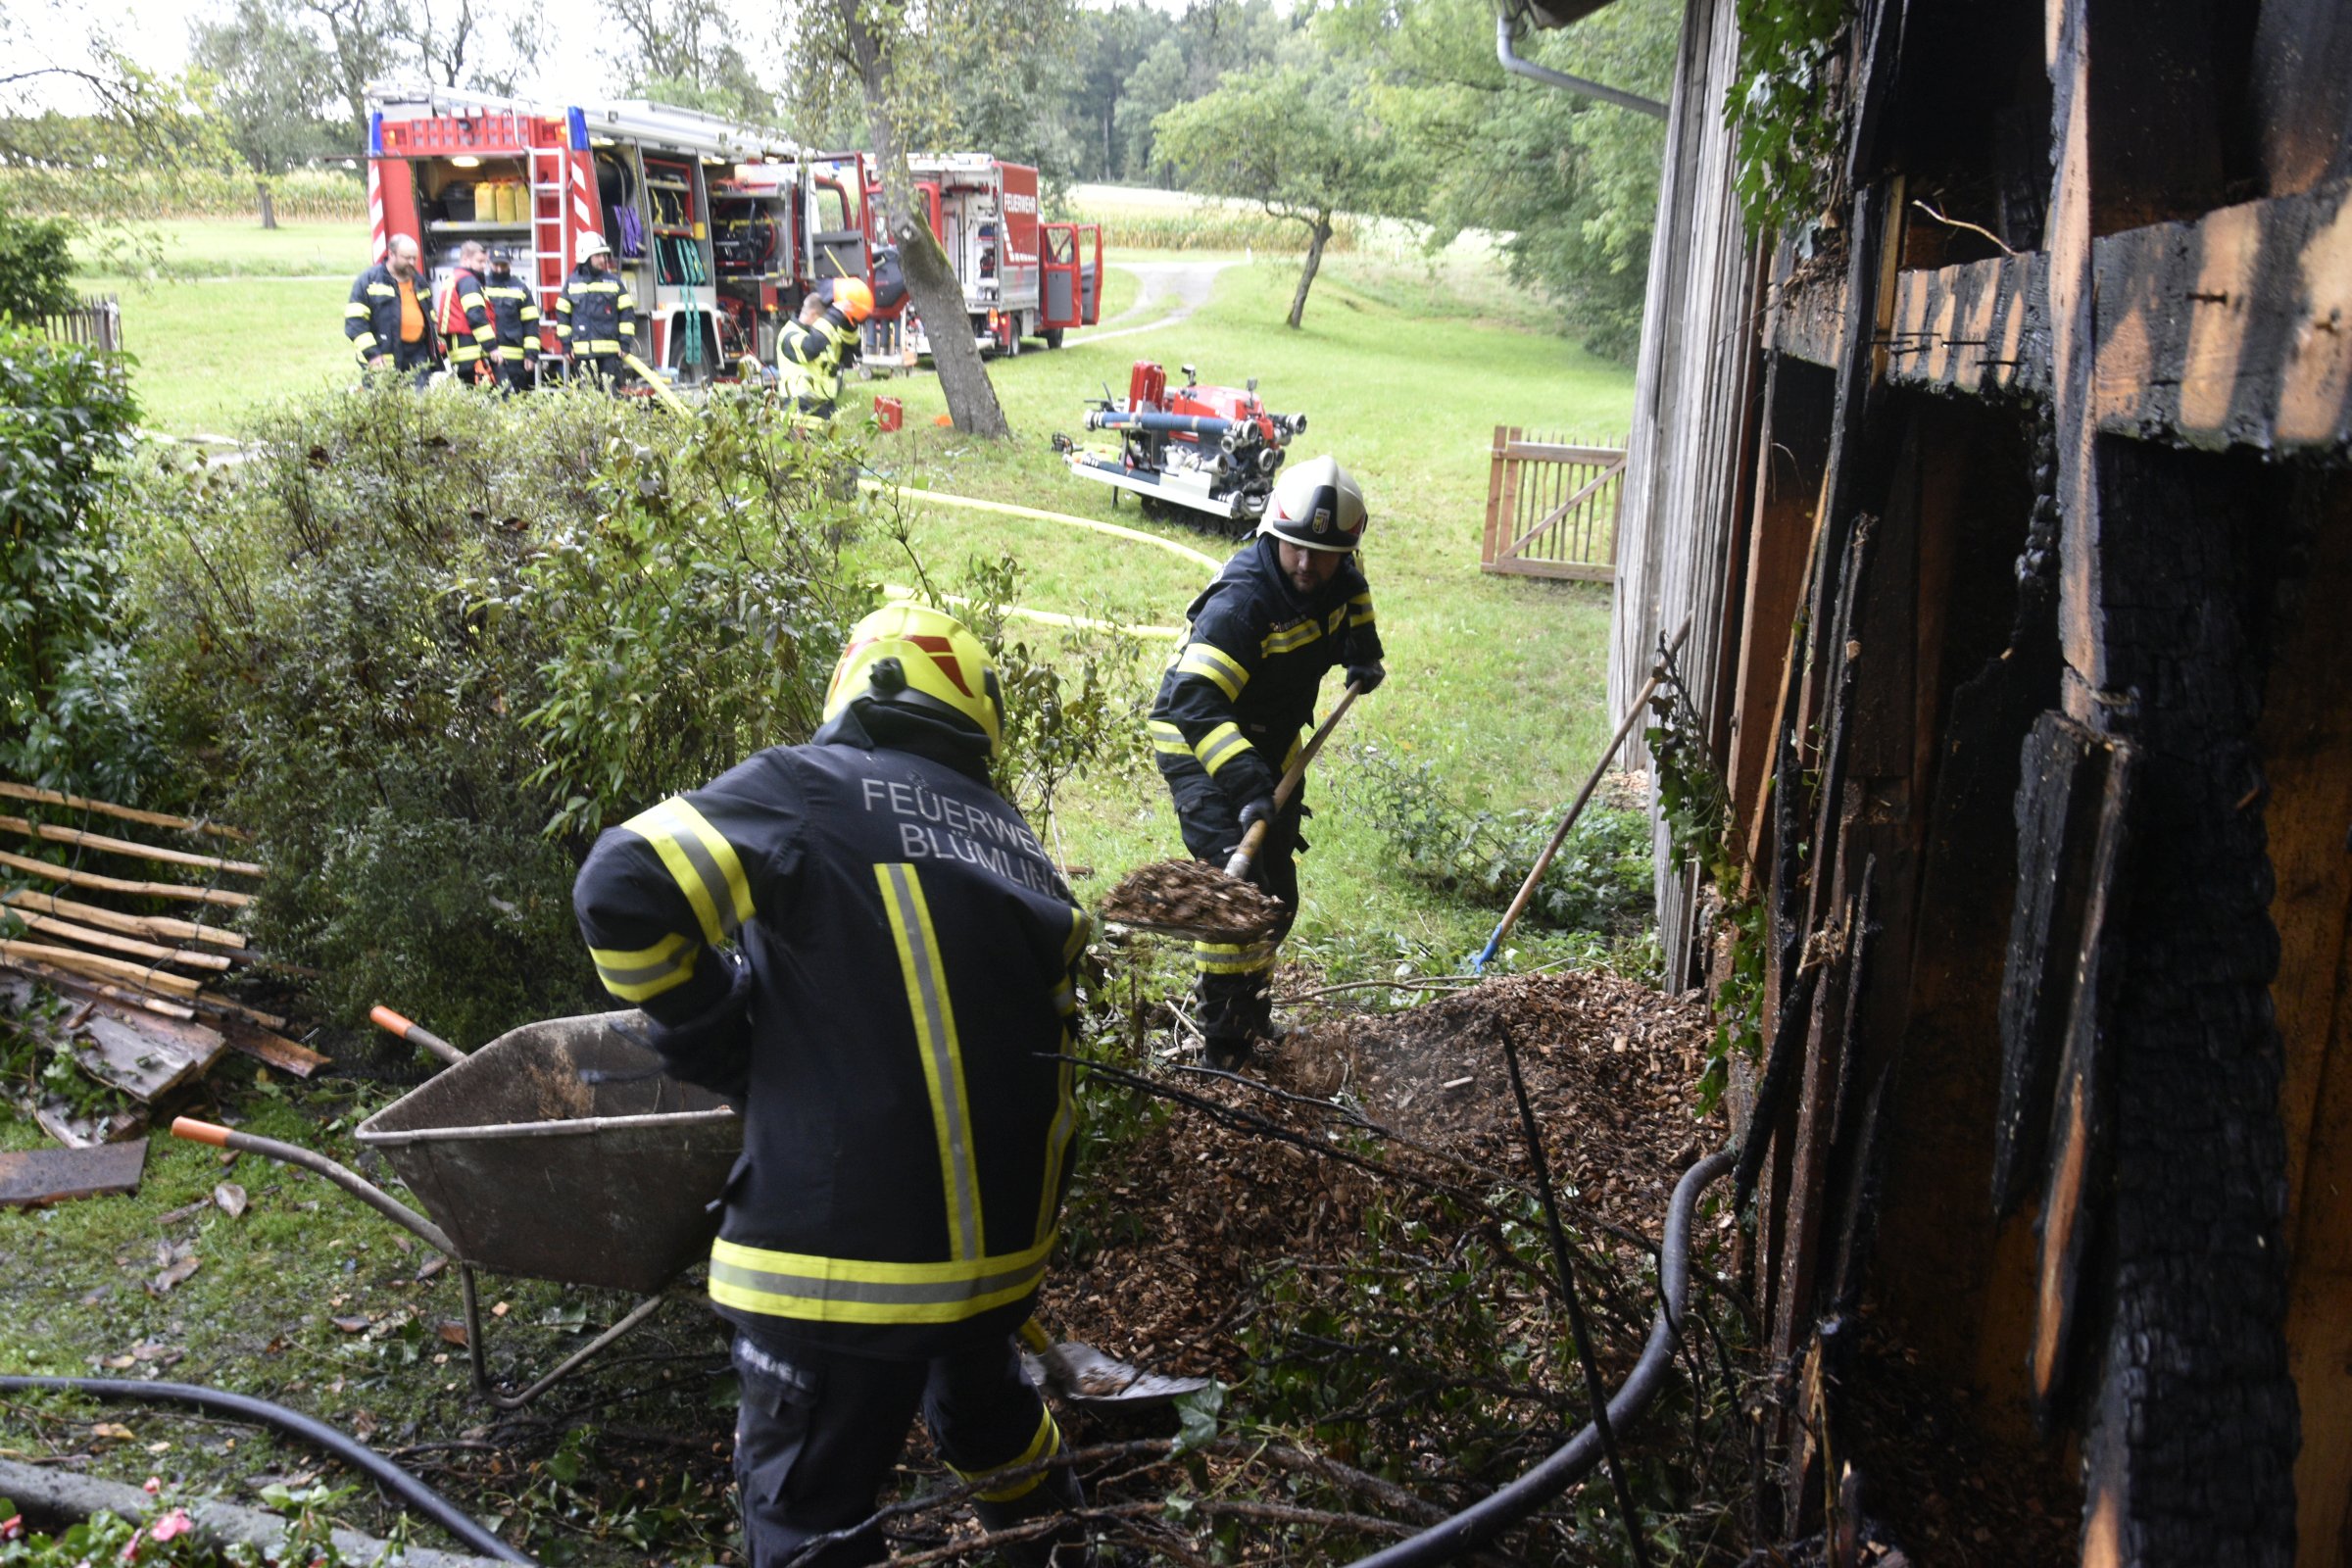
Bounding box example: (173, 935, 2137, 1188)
(734, 1328, 1084, 1568)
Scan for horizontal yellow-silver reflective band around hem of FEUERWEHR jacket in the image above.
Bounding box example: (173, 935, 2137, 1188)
(710, 1232, 1060, 1324)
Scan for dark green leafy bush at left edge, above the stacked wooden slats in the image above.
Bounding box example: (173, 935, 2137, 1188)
(0, 324, 143, 795)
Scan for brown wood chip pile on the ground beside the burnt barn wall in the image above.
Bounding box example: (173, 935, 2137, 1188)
(1040, 971, 1727, 1382)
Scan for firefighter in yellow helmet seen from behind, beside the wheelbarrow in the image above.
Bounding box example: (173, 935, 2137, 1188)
(574, 604, 1089, 1568)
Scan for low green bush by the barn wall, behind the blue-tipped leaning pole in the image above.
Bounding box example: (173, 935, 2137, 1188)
(1343, 745, 1656, 936)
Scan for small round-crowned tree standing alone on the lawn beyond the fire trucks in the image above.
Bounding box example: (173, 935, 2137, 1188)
(1152, 64, 1411, 329)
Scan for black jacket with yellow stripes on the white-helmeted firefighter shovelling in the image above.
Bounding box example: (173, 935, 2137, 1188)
(1151, 534, 1381, 807)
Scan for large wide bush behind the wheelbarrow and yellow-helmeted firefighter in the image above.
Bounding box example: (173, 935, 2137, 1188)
(119, 385, 868, 1044)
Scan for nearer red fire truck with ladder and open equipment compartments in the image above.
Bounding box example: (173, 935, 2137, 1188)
(367, 82, 880, 381)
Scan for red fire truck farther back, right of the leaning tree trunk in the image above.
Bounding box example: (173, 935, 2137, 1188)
(906, 153, 1103, 355)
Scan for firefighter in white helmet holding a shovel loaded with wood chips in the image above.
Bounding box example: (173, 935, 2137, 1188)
(1151, 459, 1386, 1067)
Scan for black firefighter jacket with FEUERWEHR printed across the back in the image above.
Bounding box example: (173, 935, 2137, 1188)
(574, 736, 1089, 1359)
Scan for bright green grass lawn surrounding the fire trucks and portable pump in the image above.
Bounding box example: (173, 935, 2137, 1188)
(89, 208, 1633, 956)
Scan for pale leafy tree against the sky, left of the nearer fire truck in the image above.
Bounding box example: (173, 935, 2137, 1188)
(188, 0, 353, 174)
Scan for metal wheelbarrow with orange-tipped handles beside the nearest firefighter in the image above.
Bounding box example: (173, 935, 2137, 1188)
(172, 1008, 743, 1410)
